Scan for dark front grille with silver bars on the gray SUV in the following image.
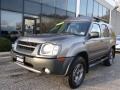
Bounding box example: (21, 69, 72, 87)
(17, 41, 38, 53)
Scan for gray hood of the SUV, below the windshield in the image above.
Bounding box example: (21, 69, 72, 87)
(19, 33, 85, 43)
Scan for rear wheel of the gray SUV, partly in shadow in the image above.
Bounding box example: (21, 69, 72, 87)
(104, 49, 115, 66)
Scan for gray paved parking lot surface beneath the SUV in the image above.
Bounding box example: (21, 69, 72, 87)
(0, 54, 120, 90)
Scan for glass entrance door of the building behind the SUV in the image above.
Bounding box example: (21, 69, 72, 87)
(24, 17, 36, 35)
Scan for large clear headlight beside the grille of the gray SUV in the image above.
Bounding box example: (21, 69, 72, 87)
(40, 43, 60, 56)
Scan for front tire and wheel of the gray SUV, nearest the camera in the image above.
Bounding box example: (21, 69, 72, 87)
(68, 57, 86, 89)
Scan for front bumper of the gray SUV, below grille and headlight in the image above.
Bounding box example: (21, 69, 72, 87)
(11, 52, 73, 75)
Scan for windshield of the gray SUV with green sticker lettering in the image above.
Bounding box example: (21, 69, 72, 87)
(47, 22, 90, 36)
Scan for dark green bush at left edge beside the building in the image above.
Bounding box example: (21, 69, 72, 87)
(0, 37, 12, 52)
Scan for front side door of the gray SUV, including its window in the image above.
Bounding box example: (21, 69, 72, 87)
(86, 24, 104, 62)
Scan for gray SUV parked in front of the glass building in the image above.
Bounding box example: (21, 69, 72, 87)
(12, 17, 116, 88)
